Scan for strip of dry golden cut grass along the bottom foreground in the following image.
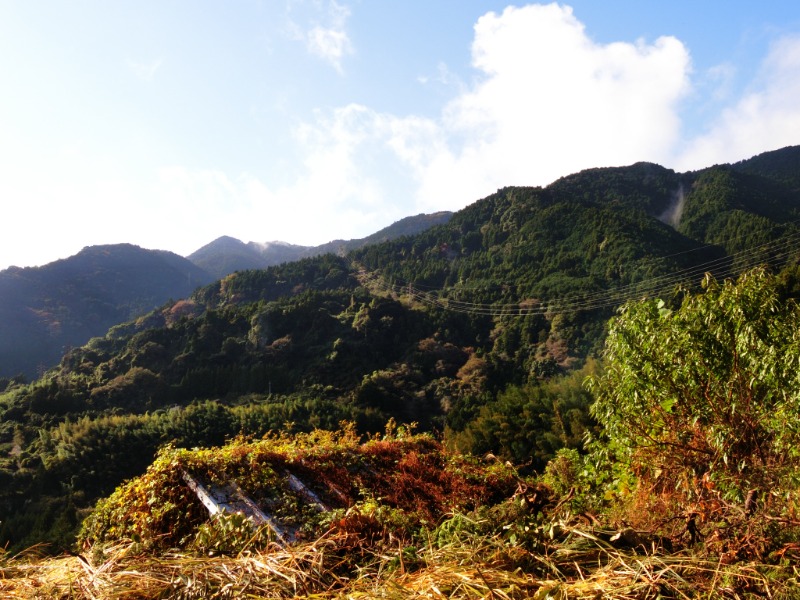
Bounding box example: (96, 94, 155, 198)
(0, 530, 800, 600)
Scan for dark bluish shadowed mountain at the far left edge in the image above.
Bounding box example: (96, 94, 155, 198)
(0, 244, 212, 379)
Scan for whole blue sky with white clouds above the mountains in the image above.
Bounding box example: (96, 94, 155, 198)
(0, 0, 800, 269)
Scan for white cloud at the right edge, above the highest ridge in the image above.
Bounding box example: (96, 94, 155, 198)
(677, 37, 800, 169)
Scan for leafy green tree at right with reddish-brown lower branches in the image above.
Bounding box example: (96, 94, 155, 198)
(589, 269, 800, 553)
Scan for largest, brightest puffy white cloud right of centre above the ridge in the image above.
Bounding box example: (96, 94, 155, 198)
(395, 4, 690, 210)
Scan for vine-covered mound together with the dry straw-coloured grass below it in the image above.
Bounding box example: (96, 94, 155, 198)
(0, 426, 800, 600)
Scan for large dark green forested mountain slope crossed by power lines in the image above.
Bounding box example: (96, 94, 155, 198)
(0, 148, 800, 546)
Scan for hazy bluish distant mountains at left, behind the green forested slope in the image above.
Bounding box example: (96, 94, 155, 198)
(0, 212, 452, 380)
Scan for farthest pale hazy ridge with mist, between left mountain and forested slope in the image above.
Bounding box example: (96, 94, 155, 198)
(187, 211, 452, 278)
